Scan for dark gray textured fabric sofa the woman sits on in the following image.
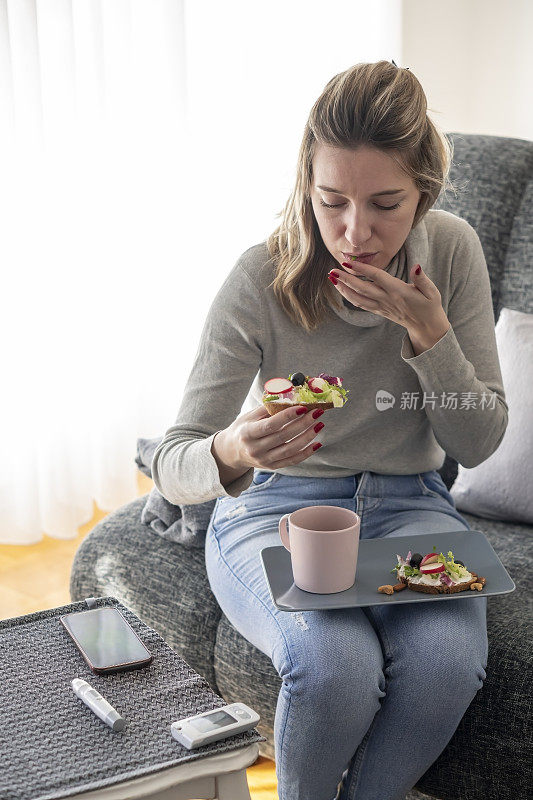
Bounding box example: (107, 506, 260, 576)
(70, 133, 533, 800)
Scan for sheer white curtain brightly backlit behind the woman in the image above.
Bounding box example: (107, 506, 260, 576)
(0, 0, 402, 544)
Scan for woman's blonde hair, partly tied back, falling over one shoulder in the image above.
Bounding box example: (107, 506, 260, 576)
(266, 61, 454, 331)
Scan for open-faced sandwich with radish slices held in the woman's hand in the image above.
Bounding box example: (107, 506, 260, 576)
(263, 372, 344, 416)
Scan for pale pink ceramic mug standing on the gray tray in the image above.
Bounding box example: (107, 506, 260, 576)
(279, 506, 361, 594)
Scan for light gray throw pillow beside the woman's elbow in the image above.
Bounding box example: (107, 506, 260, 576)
(450, 308, 533, 524)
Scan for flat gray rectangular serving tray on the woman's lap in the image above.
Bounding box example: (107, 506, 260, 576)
(260, 530, 516, 611)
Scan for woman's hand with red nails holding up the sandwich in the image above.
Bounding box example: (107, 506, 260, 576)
(215, 405, 324, 473)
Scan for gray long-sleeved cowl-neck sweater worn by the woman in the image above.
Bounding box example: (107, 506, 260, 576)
(152, 209, 508, 504)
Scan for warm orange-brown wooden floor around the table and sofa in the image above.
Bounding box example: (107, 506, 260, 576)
(0, 472, 278, 800)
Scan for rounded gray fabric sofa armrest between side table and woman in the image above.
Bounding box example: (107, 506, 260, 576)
(70, 495, 222, 694)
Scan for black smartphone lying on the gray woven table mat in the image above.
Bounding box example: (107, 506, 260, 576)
(59, 606, 153, 675)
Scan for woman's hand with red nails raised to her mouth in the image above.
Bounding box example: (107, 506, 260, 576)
(328, 261, 450, 350)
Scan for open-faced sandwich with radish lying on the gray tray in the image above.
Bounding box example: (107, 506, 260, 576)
(378, 550, 485, 594)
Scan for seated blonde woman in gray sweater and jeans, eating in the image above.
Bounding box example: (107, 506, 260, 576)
(152, 61, 507, 800)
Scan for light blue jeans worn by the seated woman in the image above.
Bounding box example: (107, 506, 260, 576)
(205, 470, 488, 800)
